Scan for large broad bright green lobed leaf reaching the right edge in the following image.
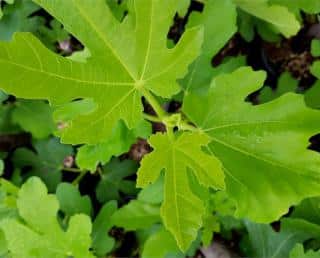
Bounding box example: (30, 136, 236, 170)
(183, 67, 320, 223)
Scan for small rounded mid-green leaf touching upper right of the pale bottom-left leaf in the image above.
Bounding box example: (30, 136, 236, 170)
(56, 183, 92, 216)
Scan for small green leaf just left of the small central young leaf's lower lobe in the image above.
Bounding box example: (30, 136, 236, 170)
(112, 200, 161, 231)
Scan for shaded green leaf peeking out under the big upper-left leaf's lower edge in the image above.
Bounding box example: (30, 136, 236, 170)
(12, 100, 55, 139)
